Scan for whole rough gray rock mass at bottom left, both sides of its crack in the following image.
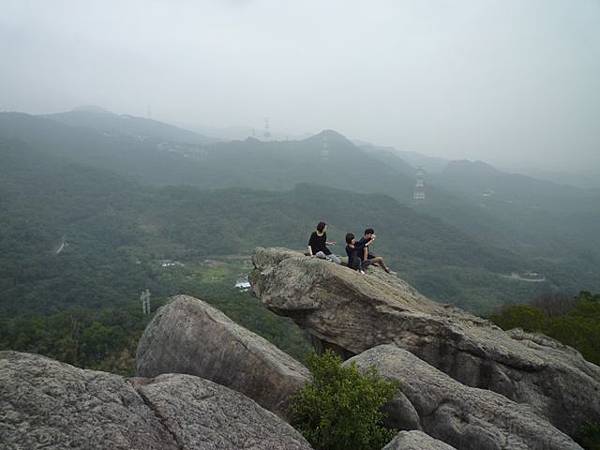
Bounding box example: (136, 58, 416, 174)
(0, 352, 311, 450)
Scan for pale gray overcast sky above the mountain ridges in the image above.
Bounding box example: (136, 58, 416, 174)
(0, 0, 600, 172)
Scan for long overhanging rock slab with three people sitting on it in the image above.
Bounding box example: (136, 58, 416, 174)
(250, 248, 600, 434)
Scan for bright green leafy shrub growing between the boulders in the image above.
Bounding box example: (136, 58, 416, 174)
(291, 351, 397, 450)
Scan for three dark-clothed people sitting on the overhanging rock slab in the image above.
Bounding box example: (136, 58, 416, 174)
(308, 222, 390, 274)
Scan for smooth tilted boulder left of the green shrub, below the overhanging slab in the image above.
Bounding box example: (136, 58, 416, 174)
(136, 295, 309, 417)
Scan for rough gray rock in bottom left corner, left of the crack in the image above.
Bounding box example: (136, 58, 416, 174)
(0, 352, 179, 450)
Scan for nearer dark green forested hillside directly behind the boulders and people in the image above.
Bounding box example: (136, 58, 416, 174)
(0, 141, 527, 374)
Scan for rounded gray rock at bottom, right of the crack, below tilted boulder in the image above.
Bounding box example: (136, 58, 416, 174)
(134, 374, 311, 450)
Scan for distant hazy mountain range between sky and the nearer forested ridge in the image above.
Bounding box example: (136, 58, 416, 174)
(0, 110, 600, 292)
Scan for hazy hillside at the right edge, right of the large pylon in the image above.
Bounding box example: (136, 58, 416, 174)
(433, 161, 600, 283)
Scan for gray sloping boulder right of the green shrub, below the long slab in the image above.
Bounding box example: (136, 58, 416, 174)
(344, 345, 581, 450)
